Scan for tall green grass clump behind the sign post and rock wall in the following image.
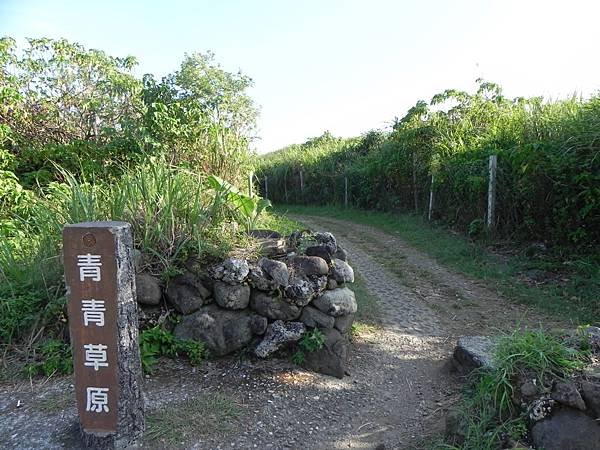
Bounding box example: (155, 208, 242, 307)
(0, 158, 255, 352)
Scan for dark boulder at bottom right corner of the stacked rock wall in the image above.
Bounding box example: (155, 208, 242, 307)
(302, 328, 349, 378)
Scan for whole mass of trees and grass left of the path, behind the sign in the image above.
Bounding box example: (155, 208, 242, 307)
(0, 38, 269, 377)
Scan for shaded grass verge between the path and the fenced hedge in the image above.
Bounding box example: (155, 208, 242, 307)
(276, 205, 600, 324)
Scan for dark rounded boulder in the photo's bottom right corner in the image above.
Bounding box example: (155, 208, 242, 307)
(531, 409, 600, 450)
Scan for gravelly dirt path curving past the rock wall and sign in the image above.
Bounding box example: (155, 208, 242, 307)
(0, 217, 554, 449)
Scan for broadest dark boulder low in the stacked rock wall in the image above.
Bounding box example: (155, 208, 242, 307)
(173, 304, 267, 356)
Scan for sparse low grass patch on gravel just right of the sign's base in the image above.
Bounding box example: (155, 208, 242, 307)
(144, 393, 243, 446)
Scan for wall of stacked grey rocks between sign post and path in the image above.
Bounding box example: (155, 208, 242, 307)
(137, 233, 357, 378)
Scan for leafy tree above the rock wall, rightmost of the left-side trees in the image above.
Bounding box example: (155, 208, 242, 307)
(143, 52, 258, 182)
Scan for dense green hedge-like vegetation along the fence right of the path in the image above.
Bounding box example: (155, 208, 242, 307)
(257, 81, 600, 254)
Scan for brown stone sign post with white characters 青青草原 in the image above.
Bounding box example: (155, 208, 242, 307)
(63, 222, 144, 449)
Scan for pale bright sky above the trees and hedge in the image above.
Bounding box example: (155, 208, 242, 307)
(0, 0, 600, 152)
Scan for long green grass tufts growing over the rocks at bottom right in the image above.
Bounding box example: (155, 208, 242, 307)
(431, 330, 589, 450)
